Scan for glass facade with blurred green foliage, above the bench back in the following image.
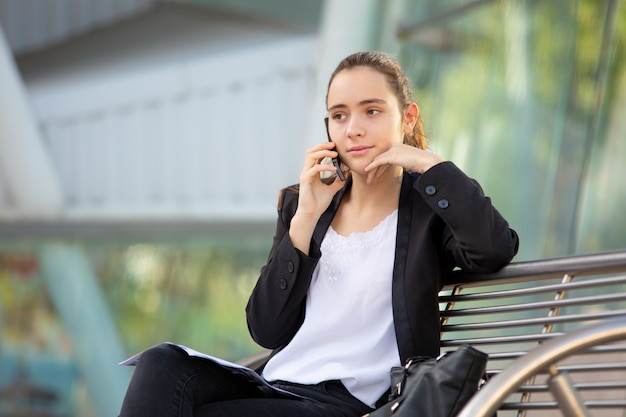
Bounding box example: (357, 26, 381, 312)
(398, 0, 626, 259)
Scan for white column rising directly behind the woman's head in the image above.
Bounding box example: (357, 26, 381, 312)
(303, 0, 379, 145)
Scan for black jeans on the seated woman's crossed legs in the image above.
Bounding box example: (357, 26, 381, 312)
(120, 344, 372, 417)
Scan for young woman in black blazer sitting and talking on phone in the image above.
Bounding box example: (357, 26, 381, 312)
(121, 51, 518, 417)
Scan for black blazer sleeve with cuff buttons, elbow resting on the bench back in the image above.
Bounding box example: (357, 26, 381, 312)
(414, 162, 519, 273)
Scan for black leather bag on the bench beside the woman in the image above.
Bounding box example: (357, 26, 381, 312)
(363, 345, 487, 417)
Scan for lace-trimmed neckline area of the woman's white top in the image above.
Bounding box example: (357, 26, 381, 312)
(320, 209, 398, 283)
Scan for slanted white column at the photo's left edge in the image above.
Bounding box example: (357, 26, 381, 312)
(0, 27, 63, 219)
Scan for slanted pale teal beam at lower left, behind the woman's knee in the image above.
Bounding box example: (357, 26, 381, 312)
(39, 243, 131, 417)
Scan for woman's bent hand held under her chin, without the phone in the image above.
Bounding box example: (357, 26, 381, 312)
(365, 143, 444, 184)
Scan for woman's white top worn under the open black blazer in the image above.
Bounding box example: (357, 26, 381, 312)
(263, 210, 400, 407)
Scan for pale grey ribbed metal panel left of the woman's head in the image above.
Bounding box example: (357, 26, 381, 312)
(30, 36, 314, 220)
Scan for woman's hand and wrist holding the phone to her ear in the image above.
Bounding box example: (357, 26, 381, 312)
(289, 142, 345, 254)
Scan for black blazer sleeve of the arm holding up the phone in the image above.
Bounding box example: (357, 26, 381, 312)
(246, 188, 321, 349)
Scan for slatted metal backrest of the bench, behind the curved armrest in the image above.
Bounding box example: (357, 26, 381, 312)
(440, 251, 626, 417)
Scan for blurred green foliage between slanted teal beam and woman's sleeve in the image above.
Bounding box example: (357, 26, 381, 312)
(98, 244, 266, 360)
